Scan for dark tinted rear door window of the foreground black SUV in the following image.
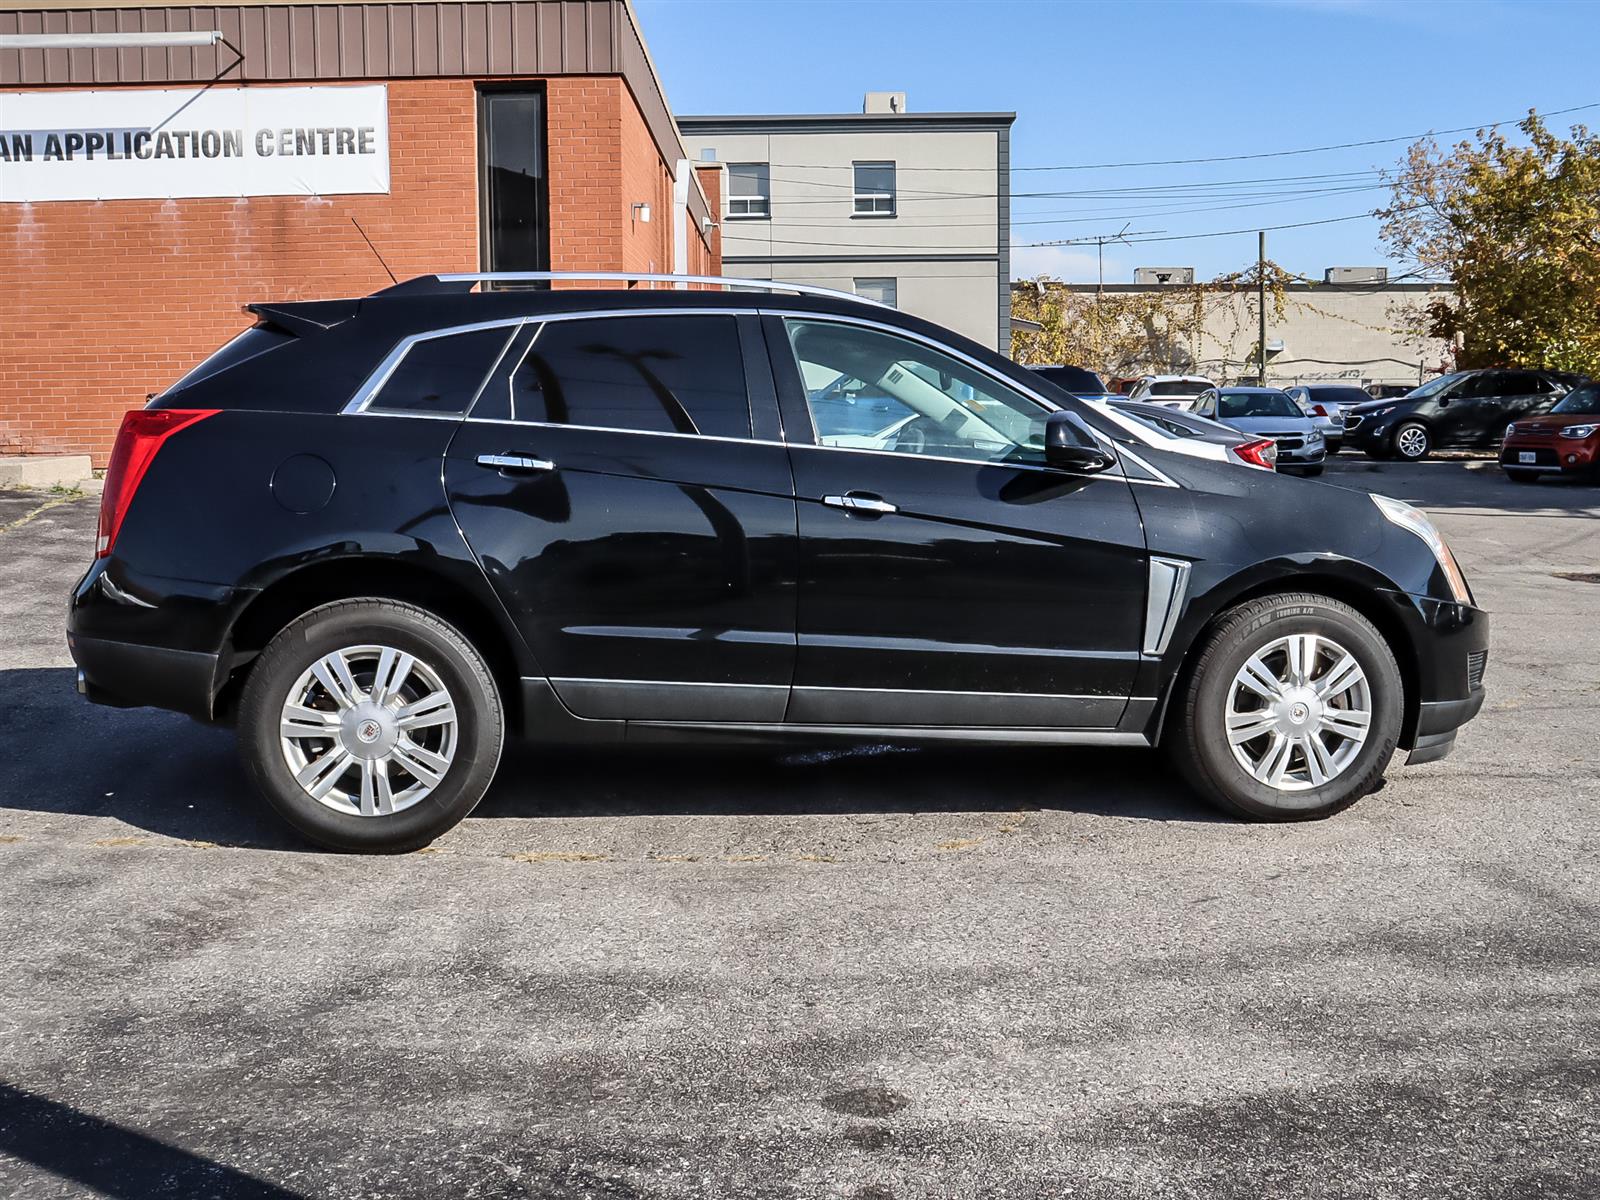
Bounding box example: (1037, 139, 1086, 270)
(510, 315, 750, 438)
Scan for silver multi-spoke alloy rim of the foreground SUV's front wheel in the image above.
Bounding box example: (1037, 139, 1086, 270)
(1226, 634, 1373, 792)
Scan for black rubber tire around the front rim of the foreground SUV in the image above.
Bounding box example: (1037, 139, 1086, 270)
(1163, 592, 1405, 821)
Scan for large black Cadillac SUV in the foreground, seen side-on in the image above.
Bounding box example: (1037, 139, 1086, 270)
(69, 275, 1488, 851)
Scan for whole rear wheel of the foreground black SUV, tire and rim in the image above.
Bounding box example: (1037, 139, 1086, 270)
(238, 600, 504, 853)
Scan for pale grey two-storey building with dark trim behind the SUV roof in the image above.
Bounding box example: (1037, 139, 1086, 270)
(678, 91, 1016, 352)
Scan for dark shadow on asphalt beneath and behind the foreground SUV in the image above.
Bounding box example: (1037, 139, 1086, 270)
(0, 667, 1222, 850)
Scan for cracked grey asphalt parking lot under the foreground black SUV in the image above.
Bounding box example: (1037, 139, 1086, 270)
(0, 459, 1600, 1200)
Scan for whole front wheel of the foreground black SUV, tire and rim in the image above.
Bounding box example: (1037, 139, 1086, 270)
(1166, 594, 1405, 821)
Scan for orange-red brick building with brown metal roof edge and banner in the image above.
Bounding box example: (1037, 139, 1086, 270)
(0, 0, 720, 466)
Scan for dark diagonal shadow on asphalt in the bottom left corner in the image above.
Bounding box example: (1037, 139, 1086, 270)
(0, 1083, 301, 1200)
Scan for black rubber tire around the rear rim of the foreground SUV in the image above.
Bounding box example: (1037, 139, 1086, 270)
(238, 598, 506, 854)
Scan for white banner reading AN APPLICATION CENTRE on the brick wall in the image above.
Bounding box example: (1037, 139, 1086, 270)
(0, 85, 389, 203)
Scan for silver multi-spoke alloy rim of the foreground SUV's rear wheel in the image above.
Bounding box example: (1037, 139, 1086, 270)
(278, 646, 459, 816)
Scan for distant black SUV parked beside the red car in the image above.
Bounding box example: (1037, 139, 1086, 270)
(1344, 370, 1582, 462)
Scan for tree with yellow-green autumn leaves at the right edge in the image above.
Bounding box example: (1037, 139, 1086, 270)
(1378, 112, 1600, 374)
